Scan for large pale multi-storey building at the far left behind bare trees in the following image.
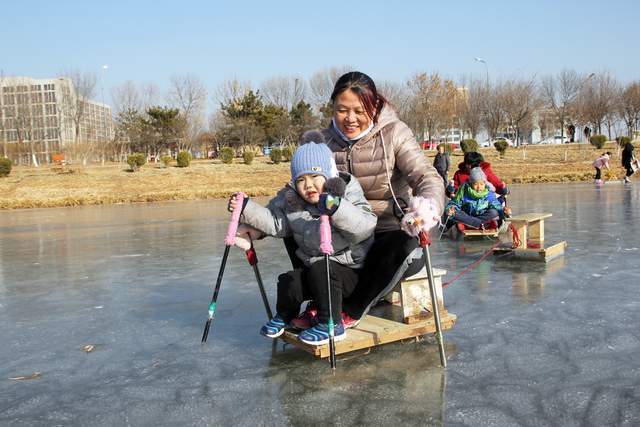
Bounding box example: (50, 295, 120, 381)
(0, 76, 113, 162)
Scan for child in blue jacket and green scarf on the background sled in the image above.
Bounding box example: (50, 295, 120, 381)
(445, 167, 511, 228)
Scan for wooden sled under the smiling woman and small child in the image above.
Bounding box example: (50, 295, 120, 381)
(280, 268, 457, 358)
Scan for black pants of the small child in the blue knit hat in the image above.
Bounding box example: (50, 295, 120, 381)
(276, 259, 358, 323)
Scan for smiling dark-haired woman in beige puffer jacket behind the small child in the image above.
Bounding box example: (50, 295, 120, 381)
(296, 71, 444, 327)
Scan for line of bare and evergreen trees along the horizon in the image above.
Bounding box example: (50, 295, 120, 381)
(0, 66, 640, 167)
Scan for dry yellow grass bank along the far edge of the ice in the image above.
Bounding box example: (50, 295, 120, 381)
(0, 144, 623, 209)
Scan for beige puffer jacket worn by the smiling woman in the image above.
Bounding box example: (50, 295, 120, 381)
(312, 105, 444, 233)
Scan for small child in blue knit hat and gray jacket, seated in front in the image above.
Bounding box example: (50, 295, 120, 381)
(229, 142, 377, 345)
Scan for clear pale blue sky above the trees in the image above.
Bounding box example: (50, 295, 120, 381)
(0, 0, 640, 112)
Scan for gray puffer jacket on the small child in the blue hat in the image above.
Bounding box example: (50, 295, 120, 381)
(242, 172, 377, 268)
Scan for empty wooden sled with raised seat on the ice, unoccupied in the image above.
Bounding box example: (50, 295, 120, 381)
(493, 213, 567, 262)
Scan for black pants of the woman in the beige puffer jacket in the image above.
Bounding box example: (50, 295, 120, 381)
(343, 230, 424, 319)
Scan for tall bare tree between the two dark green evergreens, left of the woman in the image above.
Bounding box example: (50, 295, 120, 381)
(169, 74, 207, 149)
